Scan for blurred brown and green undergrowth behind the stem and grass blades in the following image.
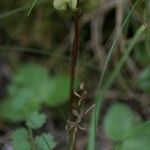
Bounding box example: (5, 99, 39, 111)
(0, 0, 150, 150)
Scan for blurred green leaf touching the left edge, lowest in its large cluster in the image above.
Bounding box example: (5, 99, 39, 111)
(0, 89, 40, 122)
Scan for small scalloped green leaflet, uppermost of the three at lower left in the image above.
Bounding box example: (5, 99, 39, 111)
(26, 112, 46, 129)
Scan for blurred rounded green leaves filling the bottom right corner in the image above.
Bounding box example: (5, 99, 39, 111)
(103, 103, 150, 150)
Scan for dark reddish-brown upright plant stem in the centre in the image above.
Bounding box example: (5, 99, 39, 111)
(69, 0, 79, 150)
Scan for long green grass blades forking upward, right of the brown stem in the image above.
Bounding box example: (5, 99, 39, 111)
(87, 0, 145, 150)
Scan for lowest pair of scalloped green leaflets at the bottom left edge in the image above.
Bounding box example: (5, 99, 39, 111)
(11, 128, 56, 150)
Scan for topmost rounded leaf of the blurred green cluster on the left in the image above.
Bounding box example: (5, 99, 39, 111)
(11, 64, 51, 100)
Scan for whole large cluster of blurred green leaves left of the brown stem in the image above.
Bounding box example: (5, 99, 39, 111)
(0, 64, 69, 122)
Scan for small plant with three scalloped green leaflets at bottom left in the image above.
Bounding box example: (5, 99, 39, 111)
(11, 112, 56, 150)
